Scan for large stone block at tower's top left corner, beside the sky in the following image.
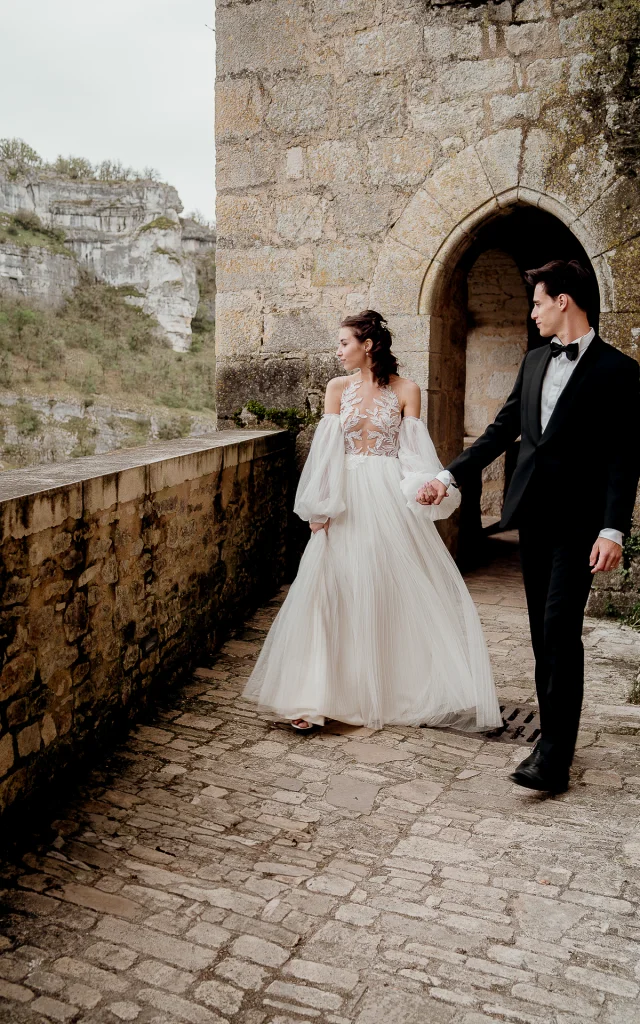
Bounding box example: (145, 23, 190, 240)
(216, 0, 307, 75)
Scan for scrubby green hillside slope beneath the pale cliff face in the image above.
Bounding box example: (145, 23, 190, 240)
(0, 280, 215, 412)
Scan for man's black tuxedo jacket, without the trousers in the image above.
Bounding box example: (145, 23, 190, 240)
(446, 336, 640, 541)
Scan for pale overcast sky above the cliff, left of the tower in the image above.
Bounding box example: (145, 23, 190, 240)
(0, 0, 215, 220)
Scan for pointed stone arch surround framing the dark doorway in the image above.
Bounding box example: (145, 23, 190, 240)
(370, 129, 623, 561)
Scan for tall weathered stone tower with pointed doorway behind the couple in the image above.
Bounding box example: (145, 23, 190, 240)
(216, 0, 640, 512)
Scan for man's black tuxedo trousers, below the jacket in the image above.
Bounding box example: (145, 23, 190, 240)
(519, 516, 598, 772)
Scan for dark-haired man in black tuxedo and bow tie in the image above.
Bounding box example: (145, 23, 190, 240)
(418, 260, 640, 793)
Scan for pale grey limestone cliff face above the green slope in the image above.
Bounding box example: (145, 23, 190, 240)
(0, 173, 213, 351)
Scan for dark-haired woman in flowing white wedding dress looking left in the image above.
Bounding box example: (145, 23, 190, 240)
(245, 309, 501, 732)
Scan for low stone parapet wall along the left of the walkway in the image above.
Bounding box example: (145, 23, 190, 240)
(0, 431, 290, 812)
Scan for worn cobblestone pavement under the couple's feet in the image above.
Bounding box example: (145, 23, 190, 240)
(0, 542, 640, 1024)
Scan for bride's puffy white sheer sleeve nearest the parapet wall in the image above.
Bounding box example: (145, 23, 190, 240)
(293, 413, 345, 522)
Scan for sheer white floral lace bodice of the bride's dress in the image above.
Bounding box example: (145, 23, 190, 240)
(340, 380, 402, 459)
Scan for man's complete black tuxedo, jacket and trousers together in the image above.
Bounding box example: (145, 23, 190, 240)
(446, 337, 640, 775)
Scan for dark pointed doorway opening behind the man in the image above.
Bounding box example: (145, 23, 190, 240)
(428, 199, 599, 567)
